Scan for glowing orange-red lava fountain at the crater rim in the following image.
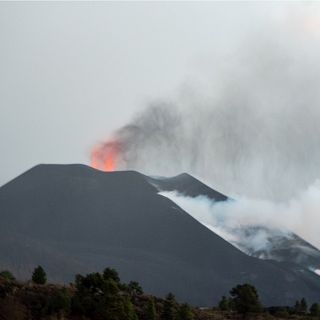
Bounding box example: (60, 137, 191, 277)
(91, 141, 120, 171)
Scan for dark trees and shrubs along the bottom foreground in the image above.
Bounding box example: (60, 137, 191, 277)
(0, 266, 320, 320)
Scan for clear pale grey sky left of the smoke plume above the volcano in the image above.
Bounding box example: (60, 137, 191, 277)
(0, 2, 318, 185)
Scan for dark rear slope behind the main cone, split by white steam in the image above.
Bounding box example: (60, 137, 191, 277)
(151, 173, 320, 270)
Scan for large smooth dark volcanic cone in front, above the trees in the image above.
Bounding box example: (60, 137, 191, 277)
(0, 165, 320, 306)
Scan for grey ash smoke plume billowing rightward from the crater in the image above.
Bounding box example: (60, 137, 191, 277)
(92, 9, 320, 201)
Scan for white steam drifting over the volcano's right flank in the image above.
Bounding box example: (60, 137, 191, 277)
(160, 182, 320, 251)
